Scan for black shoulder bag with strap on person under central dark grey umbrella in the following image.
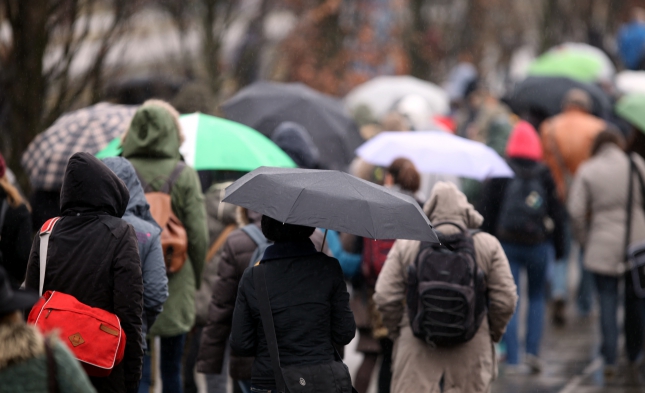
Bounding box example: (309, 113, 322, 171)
(253, 264, 357, 393)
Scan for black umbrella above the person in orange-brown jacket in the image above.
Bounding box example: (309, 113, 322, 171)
(504, 76, 611, 125)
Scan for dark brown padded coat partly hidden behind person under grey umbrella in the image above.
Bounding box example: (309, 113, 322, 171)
(196, 208, 330, 379)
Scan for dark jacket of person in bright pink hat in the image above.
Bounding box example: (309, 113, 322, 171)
(477, 158, 567, 259)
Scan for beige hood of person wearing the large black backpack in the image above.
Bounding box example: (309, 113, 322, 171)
(423, 181, 484, 229)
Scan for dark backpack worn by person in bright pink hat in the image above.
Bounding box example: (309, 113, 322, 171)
(496, 166, 548, 245)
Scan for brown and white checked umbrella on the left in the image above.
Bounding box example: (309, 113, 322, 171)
(21, 103, 136, 191)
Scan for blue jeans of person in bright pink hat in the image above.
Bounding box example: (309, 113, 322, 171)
(502, 242, 553, 364)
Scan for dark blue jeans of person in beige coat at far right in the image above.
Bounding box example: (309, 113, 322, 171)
(593, 274, 645, 365)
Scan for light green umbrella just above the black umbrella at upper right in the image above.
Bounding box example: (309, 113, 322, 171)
(528, 50, 603, 82)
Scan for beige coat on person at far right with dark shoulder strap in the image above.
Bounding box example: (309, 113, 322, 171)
(567, 144, 645, 276)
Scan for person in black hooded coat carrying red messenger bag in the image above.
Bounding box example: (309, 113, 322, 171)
(25, 153, 143, 393)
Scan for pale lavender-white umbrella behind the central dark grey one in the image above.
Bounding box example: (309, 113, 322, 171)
(356, 131, 513, 180)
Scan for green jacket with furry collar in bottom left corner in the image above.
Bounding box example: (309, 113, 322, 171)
(0, 323, 96, 393)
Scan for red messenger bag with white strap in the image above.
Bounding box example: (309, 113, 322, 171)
(27, 217, 125, 377)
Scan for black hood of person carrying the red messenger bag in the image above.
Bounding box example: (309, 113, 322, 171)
(60, 153, 130, 218)
